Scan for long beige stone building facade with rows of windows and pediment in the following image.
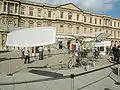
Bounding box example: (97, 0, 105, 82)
(0, 0, 120, 50)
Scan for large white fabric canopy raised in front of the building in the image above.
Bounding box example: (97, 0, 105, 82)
(6, 27, 56, 47)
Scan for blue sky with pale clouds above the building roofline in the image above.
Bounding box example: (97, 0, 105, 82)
(29, 0, 120, 18)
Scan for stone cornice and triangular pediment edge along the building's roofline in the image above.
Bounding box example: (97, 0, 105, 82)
(3, 0, 120, 20)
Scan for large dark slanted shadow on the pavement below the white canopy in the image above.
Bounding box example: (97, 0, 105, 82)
(29, 70, 63, 78)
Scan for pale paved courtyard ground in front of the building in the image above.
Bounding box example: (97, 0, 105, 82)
(0, 50, 120, 90)
